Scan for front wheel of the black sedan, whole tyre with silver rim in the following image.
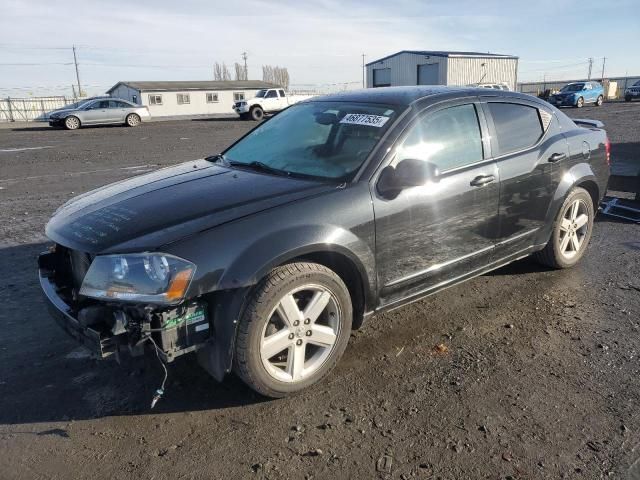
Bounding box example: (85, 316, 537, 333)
(234, 262, 352, 398)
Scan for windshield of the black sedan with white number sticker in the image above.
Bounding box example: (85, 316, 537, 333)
(224, 102, 397, 181)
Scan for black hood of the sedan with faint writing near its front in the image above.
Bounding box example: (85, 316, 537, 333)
(46, 160, 335, 254)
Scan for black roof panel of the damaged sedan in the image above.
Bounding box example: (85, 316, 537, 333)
(308, 85, 531, 106)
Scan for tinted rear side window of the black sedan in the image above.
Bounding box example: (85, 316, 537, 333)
(488, 102, 543, 155)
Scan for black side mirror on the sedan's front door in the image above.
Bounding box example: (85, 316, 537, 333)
(377, 158, 440, 196)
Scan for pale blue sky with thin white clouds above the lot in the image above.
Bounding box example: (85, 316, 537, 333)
(0, 0, 640, 97)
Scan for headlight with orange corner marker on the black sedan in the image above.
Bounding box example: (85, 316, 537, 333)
(80, 253, 196, 304)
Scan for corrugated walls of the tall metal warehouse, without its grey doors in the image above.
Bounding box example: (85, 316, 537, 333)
(367, 53, 518, 90)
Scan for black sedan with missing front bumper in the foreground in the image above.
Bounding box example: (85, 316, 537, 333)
(39, 87, 609, 397)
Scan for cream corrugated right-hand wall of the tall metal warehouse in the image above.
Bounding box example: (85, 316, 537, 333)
(447, 57, 518, 90)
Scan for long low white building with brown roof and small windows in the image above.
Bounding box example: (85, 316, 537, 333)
(107, 80, 277, 117)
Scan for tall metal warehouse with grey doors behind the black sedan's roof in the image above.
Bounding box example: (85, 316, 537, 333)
(366, 50, 518, 90)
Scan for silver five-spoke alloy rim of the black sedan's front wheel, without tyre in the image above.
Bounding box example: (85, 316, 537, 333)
(260, 285, 341, 383)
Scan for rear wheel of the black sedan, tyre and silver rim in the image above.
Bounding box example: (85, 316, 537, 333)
(533, 187, 595, 268)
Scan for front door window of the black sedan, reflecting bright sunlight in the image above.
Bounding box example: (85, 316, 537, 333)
(394, 104, 483, 172)
